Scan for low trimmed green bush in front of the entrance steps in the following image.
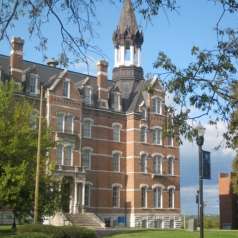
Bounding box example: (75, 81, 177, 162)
(17, 224, 96, 238)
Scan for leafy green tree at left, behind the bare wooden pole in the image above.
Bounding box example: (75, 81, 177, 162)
(0, 80, 58, 223)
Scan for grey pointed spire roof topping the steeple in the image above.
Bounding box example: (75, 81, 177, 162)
(118, 0, 138, 34)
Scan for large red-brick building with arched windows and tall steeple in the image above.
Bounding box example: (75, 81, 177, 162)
(0, 0, 181, 228)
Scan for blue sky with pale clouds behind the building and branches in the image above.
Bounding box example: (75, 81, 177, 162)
(0, 0, 236, 214)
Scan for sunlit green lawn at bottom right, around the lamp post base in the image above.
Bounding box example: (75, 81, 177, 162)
(111, 230, 238, 238)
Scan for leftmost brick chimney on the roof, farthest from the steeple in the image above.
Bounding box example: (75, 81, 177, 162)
(10, 37, 24, 82)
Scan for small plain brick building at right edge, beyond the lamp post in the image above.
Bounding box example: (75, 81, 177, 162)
(219, 173, 238, 229)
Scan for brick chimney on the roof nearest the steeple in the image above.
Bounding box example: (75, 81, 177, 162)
(97, 60, 109, 108)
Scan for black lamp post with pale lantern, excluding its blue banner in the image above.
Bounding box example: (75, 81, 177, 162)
(196, 122, 205, 238)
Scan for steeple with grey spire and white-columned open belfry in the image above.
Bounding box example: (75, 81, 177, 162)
(113, 0, 143, 80)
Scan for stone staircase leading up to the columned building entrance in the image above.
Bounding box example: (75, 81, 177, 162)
(66, 212, 105, 229)
